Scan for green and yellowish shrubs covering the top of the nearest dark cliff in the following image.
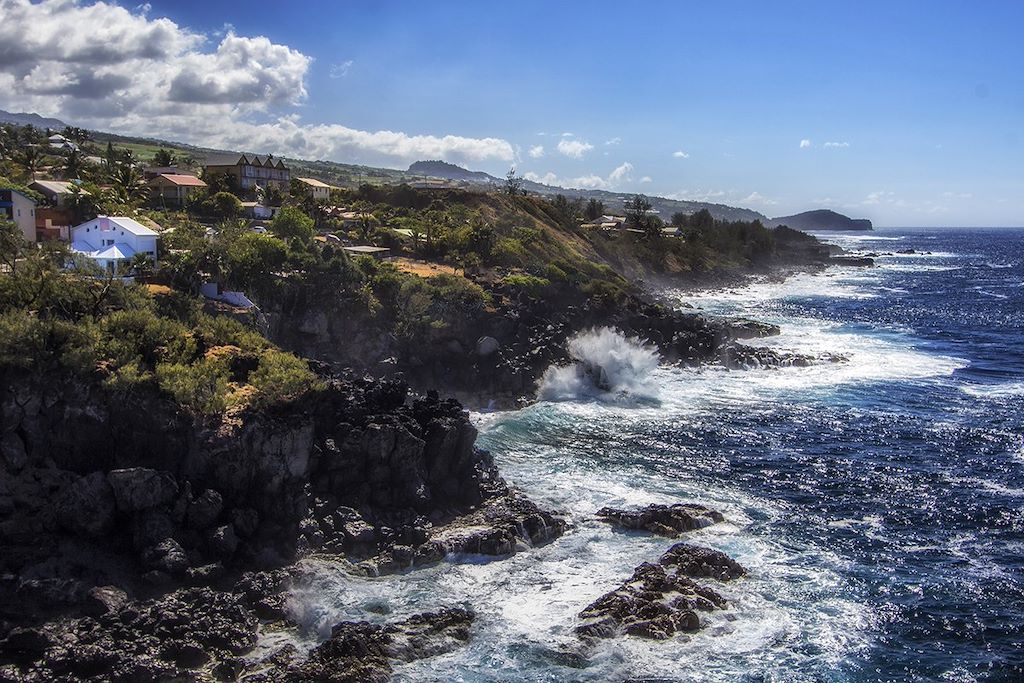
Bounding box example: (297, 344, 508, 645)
(0, 222, 319, 414)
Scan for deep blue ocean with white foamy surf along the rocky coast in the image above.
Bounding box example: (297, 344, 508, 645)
(282, 229, 1024, 682)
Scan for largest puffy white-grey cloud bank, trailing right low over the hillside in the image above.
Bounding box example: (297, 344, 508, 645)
(0, 0, 515, 163)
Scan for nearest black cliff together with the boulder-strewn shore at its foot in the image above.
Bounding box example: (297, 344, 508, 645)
(0, 370, 564, 681)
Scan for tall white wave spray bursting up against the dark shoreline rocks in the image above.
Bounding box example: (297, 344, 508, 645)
(538, 328, 660, 401)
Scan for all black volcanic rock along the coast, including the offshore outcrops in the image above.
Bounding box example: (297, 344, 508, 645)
(0, 254, 841, 681)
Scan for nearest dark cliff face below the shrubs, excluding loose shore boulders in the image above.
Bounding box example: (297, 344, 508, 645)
(0, 375, 561, 614)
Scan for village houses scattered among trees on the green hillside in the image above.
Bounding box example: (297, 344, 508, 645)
(0, 125, 696, 305)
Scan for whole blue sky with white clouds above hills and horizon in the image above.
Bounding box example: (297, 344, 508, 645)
(0, 0, 1024, 226)
